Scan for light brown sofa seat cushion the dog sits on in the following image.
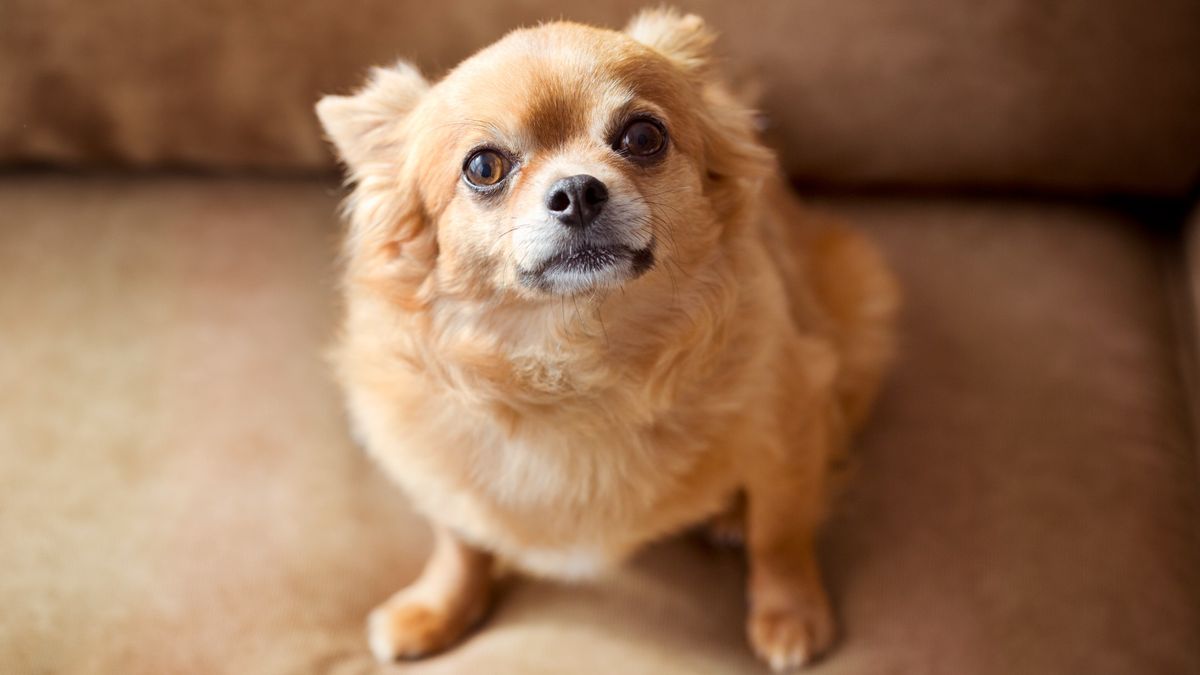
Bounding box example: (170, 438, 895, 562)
(0, 177, 1200, 675)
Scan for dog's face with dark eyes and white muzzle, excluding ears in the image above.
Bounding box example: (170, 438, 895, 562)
(427, 39, 676, 294)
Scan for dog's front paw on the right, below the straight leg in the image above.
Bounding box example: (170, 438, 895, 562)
(746, 603, 835, 673)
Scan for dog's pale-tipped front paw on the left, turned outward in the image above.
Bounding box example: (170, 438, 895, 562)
(367, 601, 469, 663)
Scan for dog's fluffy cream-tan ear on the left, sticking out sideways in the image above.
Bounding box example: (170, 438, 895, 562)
(317, 61, 430, 173)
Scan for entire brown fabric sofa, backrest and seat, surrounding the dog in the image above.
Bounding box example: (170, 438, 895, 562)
(0, 0, 1200, 675)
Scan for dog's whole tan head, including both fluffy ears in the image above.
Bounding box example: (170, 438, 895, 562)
(317, 11, 772, 301)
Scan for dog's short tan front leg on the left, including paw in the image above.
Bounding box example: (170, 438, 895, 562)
(367, 526, 492, 662)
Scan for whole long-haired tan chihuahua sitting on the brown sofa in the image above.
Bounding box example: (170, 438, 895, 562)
(317, 11, 898, 669)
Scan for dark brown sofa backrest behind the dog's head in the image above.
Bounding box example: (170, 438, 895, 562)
(0, 0, 1200, 193)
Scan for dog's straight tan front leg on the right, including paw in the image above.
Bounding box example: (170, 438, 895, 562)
(746, 398, 836, 671)
